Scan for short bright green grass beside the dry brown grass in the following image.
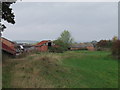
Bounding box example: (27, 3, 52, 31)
(63, 51, 118, 88)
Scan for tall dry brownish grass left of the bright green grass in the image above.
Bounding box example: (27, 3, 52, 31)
(3, 53, 60, 88)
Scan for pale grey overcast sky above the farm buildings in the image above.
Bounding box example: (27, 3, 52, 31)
(3, 2, 118, 42)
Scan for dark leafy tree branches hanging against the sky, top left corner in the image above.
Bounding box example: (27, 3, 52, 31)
(0, 0, 16, 35)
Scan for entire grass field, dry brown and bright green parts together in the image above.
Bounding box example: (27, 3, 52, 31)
(3, 51, 118, 88)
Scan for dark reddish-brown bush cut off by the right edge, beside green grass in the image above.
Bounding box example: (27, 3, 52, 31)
(112, 40, 120, 59)
